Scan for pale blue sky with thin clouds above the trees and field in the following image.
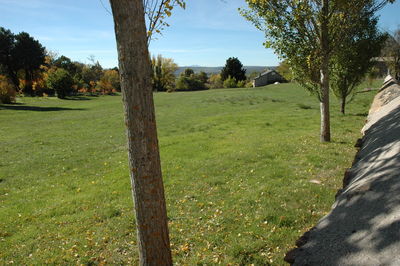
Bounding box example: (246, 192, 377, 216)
(0, 0, 400, 67)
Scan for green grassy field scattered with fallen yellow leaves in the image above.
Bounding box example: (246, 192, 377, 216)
(0, 83, 379, 265)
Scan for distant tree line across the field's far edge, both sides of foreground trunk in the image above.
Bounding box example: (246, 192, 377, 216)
(0, 27, 258, 103)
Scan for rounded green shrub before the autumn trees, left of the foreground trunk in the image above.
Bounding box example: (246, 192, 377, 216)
(46, 68, 74, 99)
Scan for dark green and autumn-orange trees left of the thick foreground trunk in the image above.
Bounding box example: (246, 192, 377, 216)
(0, 27, 120, 103)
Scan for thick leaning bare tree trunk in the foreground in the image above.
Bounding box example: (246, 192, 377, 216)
(110, 0, 172, 265)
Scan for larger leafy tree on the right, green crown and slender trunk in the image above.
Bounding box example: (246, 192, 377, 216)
(241, 0, 393, 141)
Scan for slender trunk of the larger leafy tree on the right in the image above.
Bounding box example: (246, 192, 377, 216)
(320, 0, 331, 142)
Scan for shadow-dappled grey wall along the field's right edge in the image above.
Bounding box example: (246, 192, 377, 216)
(285, 76, 400, 266)
